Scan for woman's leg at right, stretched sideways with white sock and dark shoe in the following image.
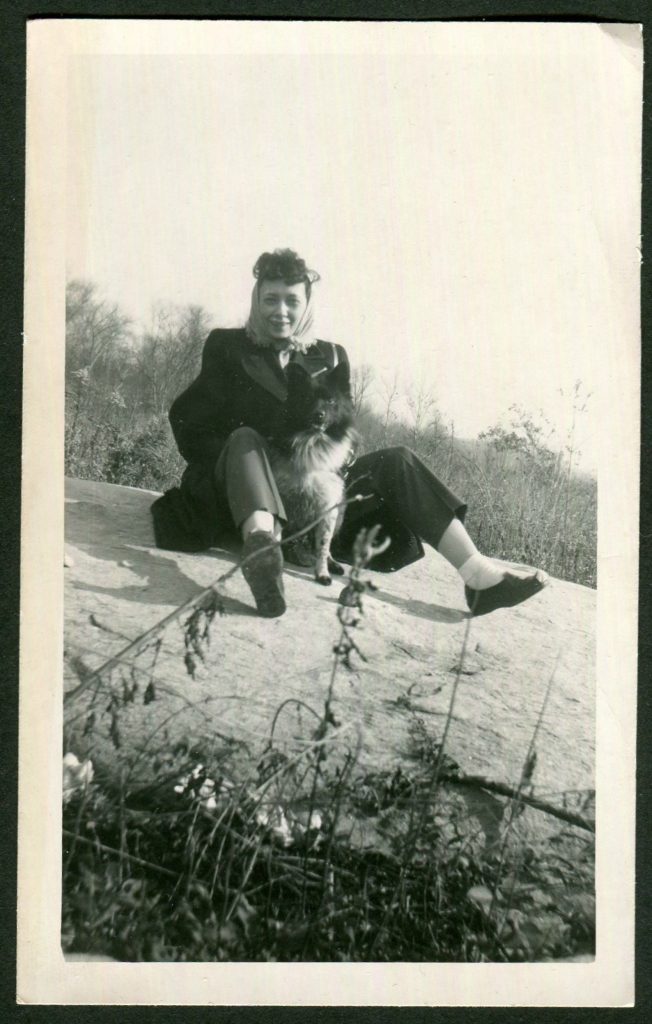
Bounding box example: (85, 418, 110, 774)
(347, 446, 545, 615)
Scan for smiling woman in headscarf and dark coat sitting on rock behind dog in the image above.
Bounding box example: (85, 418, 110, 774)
(153, 249, 546, 616)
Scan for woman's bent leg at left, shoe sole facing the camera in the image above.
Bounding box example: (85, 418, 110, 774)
(215, 427, 286, 618)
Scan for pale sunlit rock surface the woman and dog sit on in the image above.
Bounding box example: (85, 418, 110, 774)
(64, 480, 596, 835)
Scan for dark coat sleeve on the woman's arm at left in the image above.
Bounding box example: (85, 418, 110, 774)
(170, 331, 228, 462)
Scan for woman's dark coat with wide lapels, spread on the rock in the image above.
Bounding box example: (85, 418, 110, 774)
(151, 328, 423, 569)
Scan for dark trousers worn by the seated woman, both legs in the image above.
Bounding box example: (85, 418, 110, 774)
(215, 427, 467, 548)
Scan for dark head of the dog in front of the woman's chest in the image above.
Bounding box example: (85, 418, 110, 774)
(286, 362, 353, 433)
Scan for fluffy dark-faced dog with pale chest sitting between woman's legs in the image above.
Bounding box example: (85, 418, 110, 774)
(270, 362, 359, 587)
